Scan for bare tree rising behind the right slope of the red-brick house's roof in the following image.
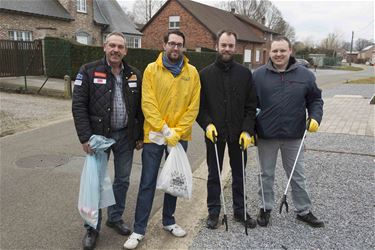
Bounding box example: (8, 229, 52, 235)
(219, 0, 295, 41)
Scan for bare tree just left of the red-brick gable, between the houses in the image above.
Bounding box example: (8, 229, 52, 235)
(133, 0, 166, 23)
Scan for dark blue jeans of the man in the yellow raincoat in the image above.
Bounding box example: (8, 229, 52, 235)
(134, 141, 188, 235)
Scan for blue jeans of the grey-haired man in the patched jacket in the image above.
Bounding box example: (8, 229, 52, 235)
(85, 130, 134, 231)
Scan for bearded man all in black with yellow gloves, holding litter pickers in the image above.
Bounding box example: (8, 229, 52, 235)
(197, 30, 257, 229)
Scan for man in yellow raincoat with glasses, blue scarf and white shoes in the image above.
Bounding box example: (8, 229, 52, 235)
(124, 30, 200, 249)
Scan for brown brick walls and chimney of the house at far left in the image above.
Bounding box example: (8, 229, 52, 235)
(0, 0, 102, 45)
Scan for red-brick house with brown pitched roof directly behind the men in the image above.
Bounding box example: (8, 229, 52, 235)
(141, 0, 277, 68)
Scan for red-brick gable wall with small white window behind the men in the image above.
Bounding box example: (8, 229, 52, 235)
(142, 1, 215, 50)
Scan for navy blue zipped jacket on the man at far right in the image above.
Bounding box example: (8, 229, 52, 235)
(253, 57, 323, 139)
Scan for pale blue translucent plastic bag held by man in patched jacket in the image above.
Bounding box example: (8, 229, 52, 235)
(78, 135, 116, 229)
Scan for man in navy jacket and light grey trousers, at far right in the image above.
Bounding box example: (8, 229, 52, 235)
(254, 37, 324, 227)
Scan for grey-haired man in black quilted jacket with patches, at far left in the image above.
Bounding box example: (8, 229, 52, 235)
(72, 32, 144, 249)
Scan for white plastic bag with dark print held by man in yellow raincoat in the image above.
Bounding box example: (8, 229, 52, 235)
(156, 143, 193, 199)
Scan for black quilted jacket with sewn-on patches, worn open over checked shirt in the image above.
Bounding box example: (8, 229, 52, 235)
(72, 58, 144, 146)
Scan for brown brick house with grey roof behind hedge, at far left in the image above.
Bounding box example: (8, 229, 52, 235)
(0, 0, 142, 48)
